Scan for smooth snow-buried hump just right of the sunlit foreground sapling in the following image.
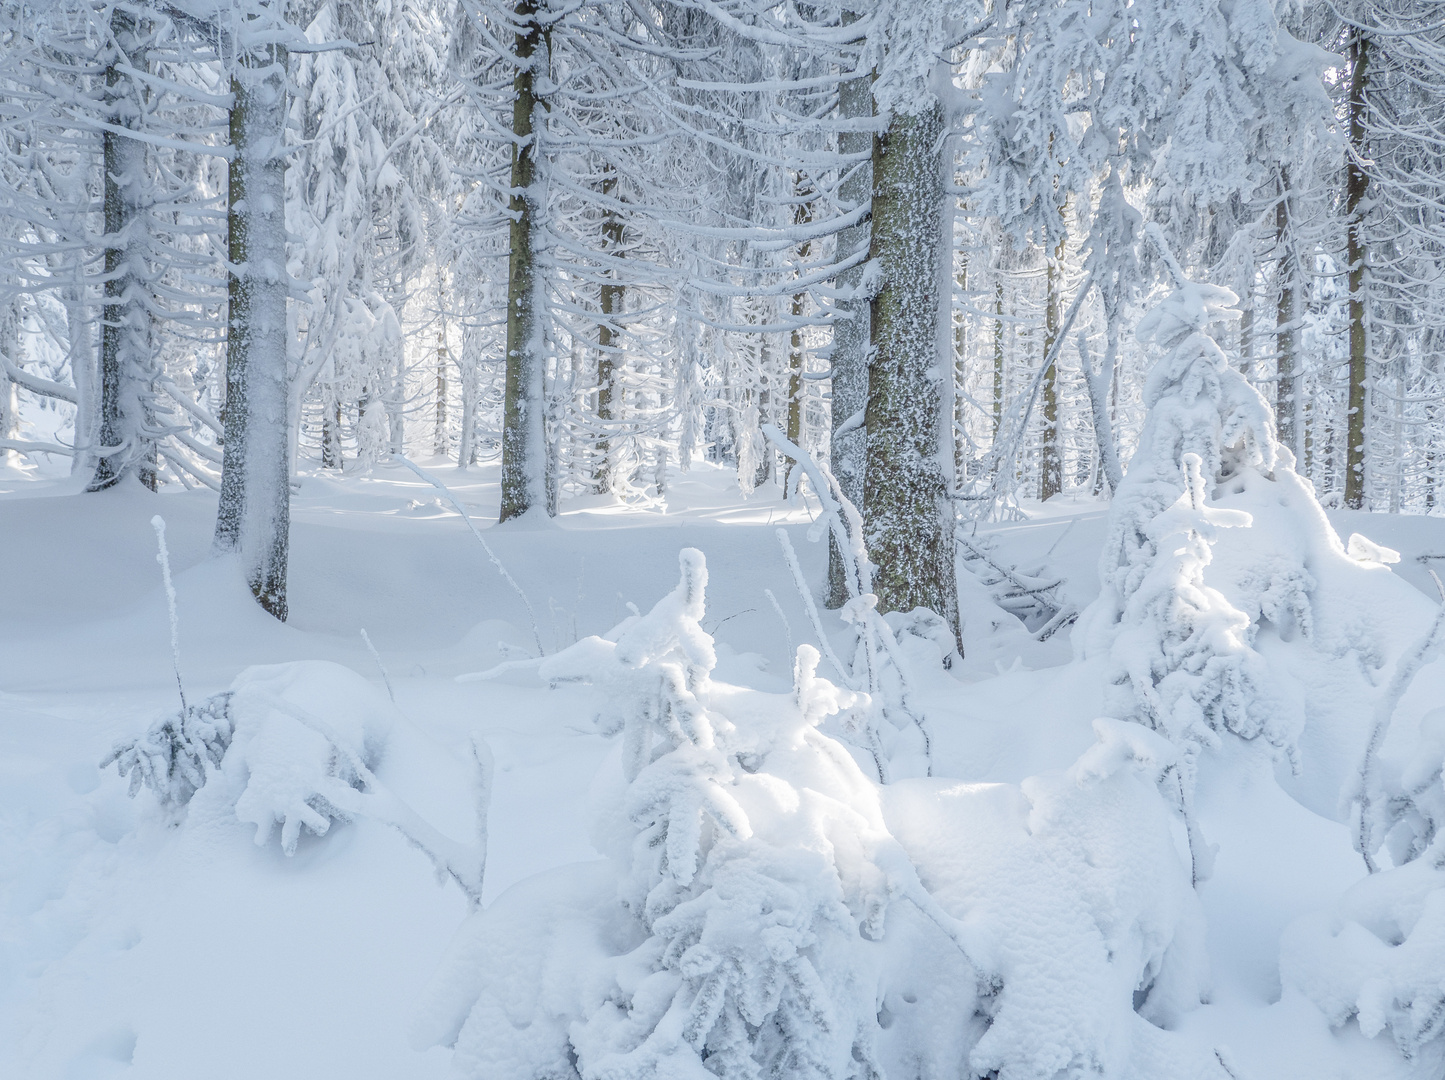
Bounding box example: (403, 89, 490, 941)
(884, 719, 1225, 1080)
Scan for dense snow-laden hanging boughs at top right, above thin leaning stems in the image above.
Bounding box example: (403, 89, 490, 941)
(964, 0, 1328, 510)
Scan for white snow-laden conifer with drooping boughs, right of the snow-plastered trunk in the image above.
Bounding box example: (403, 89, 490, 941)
(286, 3, 449, 464)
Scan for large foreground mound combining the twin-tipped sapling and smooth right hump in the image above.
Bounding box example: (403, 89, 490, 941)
(418, 551, 1222, 1080)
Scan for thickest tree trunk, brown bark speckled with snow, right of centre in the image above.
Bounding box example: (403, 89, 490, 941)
(863, 101, 958, 635)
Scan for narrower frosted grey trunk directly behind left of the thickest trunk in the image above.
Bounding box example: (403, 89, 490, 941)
(828, 33, 873, 607)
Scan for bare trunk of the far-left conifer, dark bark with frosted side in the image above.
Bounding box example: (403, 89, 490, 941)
(85, 7, 158, 492)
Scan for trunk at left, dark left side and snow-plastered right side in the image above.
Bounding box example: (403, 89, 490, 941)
(214, 33, 290, 620)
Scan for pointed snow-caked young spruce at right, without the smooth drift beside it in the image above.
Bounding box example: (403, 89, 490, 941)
(1078, 282, 1318, 766)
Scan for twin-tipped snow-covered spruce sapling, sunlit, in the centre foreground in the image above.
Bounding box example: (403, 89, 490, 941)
(534, 549, 982, 1080)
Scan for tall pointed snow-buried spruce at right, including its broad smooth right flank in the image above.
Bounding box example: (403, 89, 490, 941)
(1075, 274, 1431, 815)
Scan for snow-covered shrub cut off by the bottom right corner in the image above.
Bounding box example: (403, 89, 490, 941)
(1280, 841, 1445, 1080)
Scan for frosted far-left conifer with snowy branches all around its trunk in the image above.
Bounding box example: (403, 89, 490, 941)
(0, 3, 225, 489)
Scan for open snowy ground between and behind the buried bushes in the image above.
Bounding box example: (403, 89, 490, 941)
(0, 463, 1445, 1080)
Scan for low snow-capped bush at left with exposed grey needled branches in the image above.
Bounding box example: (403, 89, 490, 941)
(103, 661, 396, 854)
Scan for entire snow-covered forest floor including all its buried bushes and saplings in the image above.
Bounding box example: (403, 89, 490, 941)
(0, 451, 1445, 1080)
